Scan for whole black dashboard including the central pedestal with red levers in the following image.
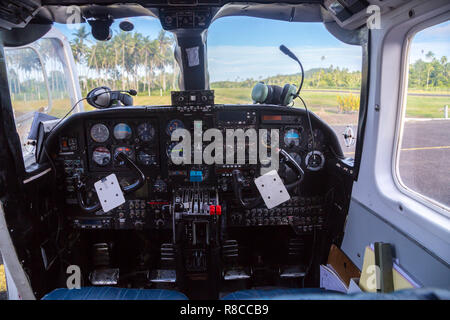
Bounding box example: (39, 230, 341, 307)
(42, 105, 348, 290)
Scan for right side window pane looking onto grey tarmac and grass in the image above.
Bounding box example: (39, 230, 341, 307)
(397, 21, 450, 210)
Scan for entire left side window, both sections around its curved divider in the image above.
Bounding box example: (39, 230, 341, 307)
(5, 38, 75, 165)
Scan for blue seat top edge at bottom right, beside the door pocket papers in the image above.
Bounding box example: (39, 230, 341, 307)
(222, 288, 450, 300)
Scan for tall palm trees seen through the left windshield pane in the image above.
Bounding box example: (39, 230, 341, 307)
(70, 26, 178, 95)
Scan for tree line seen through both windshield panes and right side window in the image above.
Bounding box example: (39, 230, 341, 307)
(71, 26, 450, 95)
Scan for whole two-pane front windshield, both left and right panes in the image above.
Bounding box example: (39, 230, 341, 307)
(54, 17, 362, 157)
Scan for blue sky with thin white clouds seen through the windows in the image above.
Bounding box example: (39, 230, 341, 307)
(56, 17, 450, 82)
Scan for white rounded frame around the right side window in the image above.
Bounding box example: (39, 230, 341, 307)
(392, 14, 450, 218)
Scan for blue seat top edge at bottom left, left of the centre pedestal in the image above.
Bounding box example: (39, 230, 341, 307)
(42, 287, 188, 300)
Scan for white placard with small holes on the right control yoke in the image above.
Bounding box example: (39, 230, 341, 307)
(255, 170, 291, 209)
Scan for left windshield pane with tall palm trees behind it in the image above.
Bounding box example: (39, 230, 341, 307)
(57, 17, 179, 110)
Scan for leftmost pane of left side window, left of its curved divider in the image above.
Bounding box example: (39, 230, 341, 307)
(5, 47, 51, 159)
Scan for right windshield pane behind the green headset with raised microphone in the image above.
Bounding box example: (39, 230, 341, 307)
(208, 17, 362, 157)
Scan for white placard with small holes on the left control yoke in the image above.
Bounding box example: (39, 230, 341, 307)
(94, 173, 125, 212)
